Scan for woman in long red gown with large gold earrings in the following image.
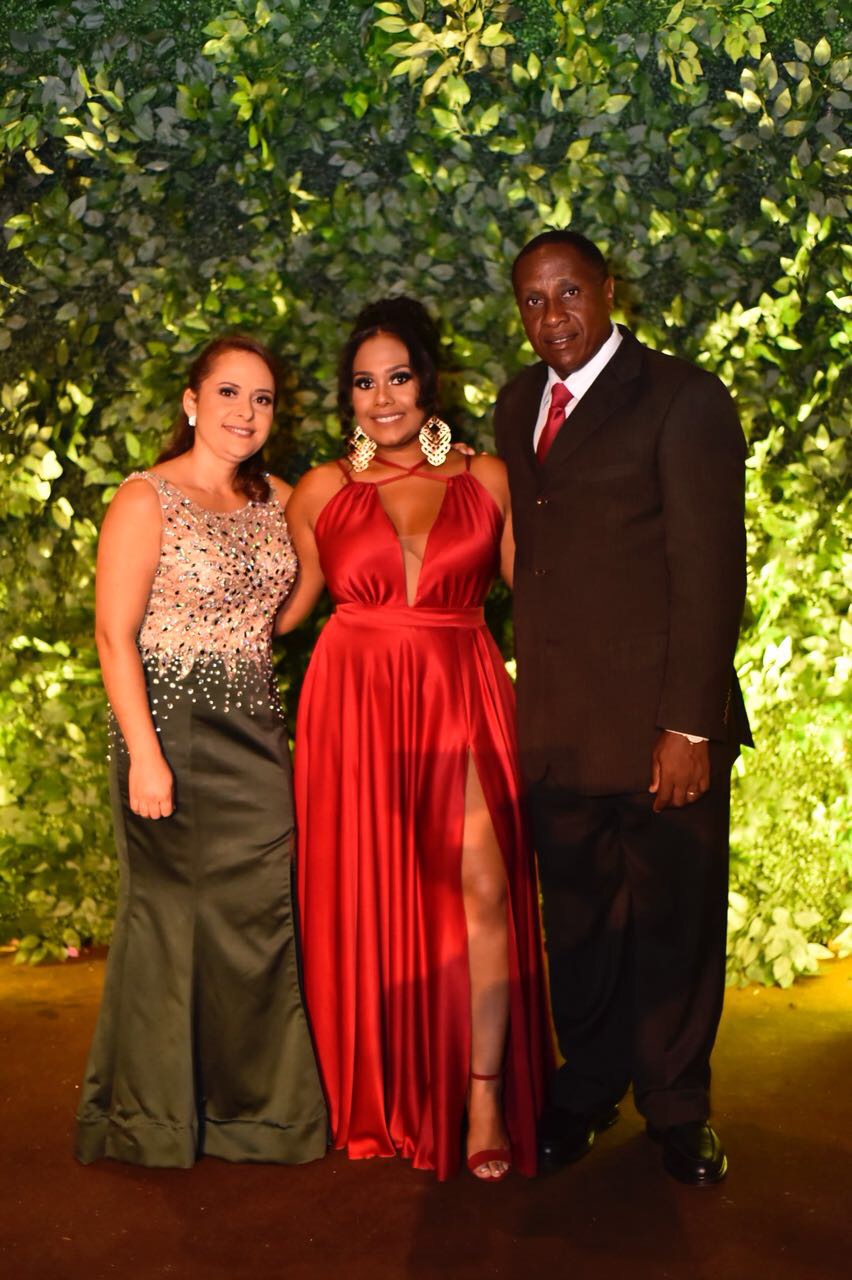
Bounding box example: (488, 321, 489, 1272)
(278, 298, 548, 1180)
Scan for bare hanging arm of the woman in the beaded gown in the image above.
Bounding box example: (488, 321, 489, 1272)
(95, 480, 174, 818)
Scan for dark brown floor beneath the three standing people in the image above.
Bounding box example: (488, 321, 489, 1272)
(0, 957, 852, 1280)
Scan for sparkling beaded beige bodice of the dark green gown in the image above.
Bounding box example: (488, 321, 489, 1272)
(124, 471, 297, 680)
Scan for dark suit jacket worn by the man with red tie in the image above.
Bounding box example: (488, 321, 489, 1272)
(495, 329, 751, 795)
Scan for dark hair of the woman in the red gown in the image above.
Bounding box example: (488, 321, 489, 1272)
(338, 296, 440, 430)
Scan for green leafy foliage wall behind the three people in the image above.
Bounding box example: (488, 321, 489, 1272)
(0, 0, 852, 983)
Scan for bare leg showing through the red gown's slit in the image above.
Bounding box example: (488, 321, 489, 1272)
(462, 758, 509, 1179)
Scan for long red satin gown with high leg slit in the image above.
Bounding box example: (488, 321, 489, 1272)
(296, 458, 549, 1179)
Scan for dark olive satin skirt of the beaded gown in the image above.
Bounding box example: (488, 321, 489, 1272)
(75, 664, 327, 1167)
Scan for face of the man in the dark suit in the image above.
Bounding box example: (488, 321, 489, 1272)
(514, 244, 614, 378)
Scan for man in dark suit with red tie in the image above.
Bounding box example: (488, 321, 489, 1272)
(495, 232, 750, 1184)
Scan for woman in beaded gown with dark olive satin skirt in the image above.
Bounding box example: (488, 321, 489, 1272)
(75, 337, 327, 1167)
